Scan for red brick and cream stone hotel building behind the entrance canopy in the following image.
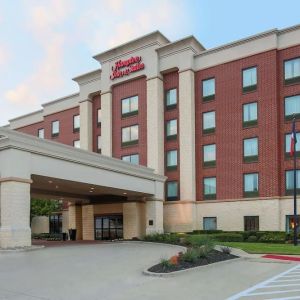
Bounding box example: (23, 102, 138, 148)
(0, 22, 300, 244)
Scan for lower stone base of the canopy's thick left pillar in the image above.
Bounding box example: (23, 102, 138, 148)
(0, 227, 31, 249)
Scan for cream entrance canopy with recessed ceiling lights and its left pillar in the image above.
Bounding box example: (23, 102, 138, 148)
(0, 128, 166, 248)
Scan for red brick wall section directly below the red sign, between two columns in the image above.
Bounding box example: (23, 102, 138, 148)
(112, 77, 147, 166)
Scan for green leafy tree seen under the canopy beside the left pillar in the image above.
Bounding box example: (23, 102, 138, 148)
(30, 198, 62, 220)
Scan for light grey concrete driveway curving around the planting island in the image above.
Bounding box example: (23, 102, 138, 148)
(0, 242, 293, 300)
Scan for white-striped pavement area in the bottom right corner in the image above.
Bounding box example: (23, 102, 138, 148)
(227, 265, 300, 300)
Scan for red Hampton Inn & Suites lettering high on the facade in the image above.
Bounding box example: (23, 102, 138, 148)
(110, 56, 145, 80)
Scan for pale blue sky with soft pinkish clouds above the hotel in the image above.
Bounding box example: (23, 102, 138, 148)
(0, 0, 300, 125)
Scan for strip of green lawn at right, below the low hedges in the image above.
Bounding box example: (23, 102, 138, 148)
(218, 242, 300, 255)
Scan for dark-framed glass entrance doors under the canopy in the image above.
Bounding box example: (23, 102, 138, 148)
(95, 215, 123, 240)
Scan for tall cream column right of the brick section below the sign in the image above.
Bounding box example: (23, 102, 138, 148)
(147, 77, 165, 175)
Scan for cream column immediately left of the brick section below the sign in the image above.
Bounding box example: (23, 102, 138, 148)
(101, 91, 112, 157)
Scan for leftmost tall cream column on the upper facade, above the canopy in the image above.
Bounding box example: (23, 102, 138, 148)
(80, 99, 93, 151)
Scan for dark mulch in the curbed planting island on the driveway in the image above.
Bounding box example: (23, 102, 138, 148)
(148, 250, 238, 273)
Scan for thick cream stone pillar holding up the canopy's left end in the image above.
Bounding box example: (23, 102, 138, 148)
(0, 177, 32, 248)
